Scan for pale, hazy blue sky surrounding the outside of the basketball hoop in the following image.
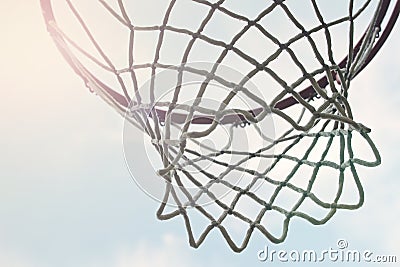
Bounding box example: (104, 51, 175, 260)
(0, 0, 400, 267)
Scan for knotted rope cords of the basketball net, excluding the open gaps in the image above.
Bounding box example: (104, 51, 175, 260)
(41, 0, 382, 251)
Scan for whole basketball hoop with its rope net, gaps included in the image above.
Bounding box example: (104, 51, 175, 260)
(41, 0, 396, 251)
